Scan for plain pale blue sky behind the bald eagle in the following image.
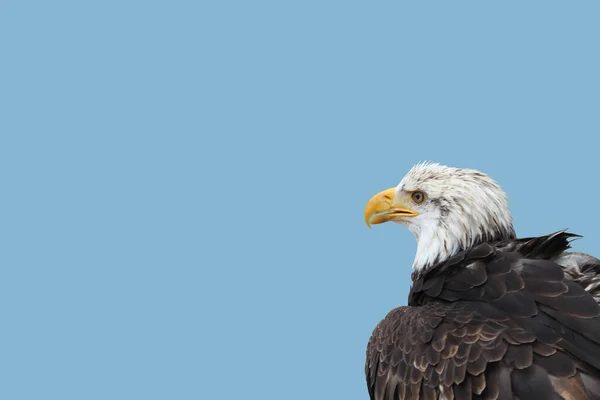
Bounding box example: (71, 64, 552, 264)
(0, 0, 600, 400)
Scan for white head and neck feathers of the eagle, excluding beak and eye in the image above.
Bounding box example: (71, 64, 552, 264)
(396, 163, 515, 271)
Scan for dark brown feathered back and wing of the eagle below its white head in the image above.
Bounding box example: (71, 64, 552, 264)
(365, 234, 600, 400)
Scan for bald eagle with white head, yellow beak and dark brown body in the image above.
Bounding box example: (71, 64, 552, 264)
(365, 163, 600, 400)
